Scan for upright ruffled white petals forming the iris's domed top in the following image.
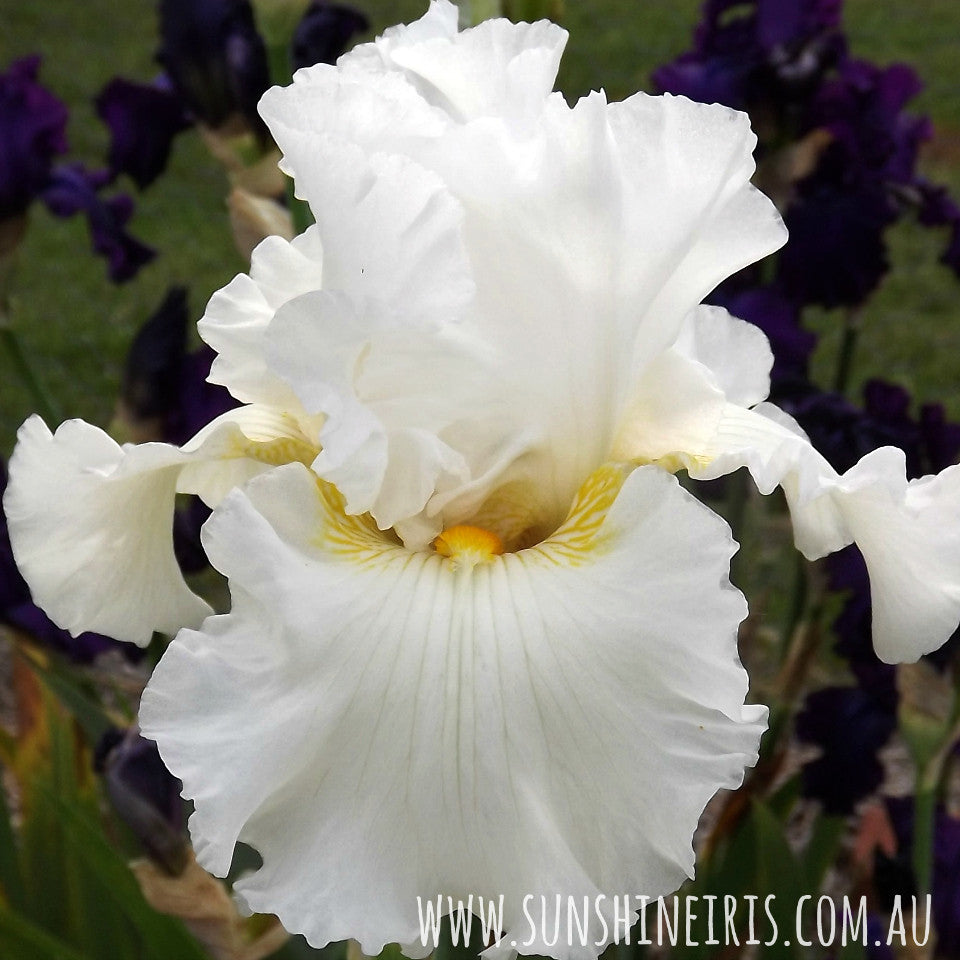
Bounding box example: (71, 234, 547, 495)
(261, 13, 785, 544)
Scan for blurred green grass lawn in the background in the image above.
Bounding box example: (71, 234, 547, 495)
(0, 0, 960, 454)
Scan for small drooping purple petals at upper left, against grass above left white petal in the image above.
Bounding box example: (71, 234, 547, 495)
(43, 164, 156, 283)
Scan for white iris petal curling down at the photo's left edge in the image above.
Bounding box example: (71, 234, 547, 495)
(3, 408, 316, 645)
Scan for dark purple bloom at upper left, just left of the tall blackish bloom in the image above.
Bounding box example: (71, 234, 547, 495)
(96, 77, 189, 190)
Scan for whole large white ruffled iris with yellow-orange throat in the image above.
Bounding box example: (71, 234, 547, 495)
(5, 0, 960, 957)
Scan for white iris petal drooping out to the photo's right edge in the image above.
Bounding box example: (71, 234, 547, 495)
(614, 308, 960, 662)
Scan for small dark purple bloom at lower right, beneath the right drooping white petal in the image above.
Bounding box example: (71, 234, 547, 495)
(796, 686, 897, 815)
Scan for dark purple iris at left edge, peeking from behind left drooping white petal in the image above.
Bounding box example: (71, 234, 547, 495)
(0, 459, 122, 663)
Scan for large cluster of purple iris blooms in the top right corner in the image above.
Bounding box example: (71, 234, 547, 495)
(654, 0, 960, 318)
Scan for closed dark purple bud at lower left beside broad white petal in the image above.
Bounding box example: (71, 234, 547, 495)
(94, 729, 187, 876)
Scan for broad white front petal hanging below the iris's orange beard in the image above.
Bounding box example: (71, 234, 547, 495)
(141, 466, 766, 957)
